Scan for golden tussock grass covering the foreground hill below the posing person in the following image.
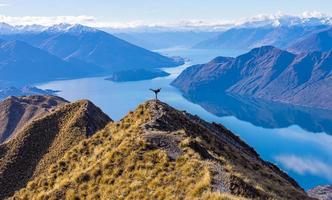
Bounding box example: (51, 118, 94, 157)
(14, 103, 241, 199)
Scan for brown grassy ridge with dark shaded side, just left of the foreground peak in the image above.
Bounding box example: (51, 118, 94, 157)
(0, 100, 111, 199)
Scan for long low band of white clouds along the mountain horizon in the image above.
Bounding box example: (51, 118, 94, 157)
(0, 11, 332, 30)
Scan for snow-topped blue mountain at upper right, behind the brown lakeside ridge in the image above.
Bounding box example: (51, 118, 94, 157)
(194, 14, 332, 51)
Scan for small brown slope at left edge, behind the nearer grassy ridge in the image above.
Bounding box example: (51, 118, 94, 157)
(0, 95, 68, 144)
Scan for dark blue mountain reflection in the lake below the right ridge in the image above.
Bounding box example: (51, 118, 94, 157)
(185, 93, 332, 135)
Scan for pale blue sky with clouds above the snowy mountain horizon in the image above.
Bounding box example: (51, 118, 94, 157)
(0, 0, 332, 27)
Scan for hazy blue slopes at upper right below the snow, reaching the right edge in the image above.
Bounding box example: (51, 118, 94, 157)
(194, 25, 331, 52)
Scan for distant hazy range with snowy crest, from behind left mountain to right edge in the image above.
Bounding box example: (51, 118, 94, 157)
(109, 13, 332, 50)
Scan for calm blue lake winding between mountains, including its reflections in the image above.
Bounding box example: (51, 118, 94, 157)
(38, 49, 332, 189)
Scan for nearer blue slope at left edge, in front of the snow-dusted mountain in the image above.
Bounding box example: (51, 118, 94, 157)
(0, 41, 105, 85)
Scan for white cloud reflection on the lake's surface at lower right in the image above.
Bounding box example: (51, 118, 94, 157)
(275, 155, 332, 181)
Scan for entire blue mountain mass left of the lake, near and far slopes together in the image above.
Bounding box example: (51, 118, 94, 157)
(0, 24, 183, 85)
